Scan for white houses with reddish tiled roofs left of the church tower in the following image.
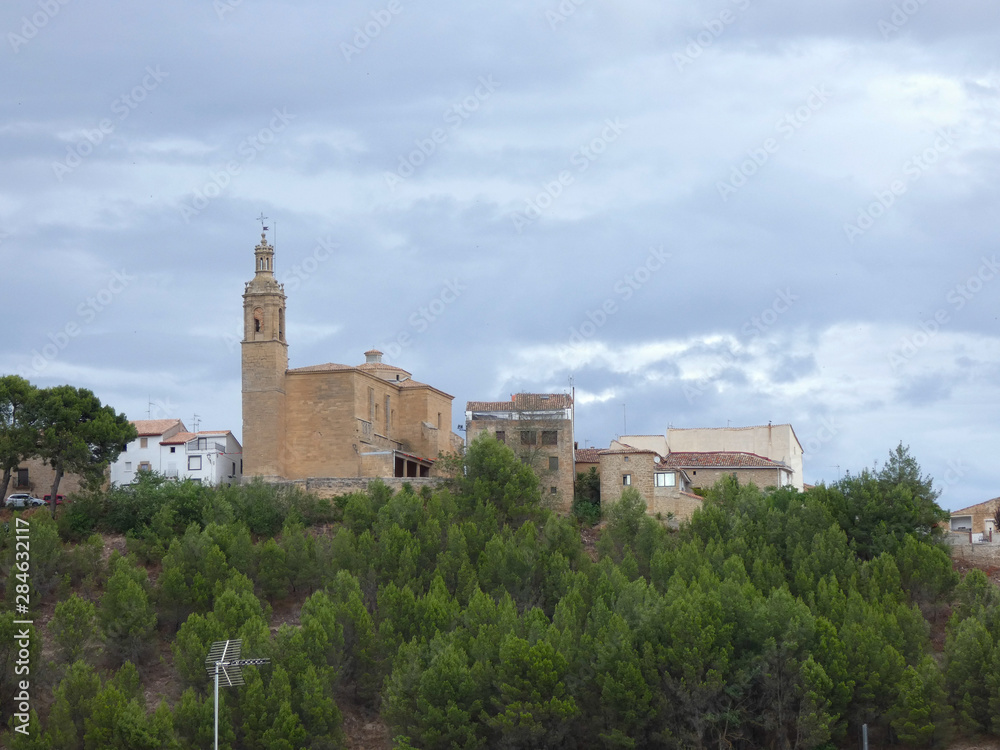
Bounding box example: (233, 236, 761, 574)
(111, 419, 243, 485)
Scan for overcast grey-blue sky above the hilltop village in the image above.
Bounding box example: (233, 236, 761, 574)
(0, 0, 1000, 509)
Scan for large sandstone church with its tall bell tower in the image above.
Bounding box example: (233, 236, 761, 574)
(241, 233, 462, 480)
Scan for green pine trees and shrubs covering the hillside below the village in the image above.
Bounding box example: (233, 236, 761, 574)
(0, 438, 1000, 750)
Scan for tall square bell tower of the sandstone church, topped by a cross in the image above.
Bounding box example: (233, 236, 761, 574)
(241, 227, 288, 477)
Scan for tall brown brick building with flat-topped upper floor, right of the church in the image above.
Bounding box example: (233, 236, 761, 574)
(465, 393, 576, 513)
